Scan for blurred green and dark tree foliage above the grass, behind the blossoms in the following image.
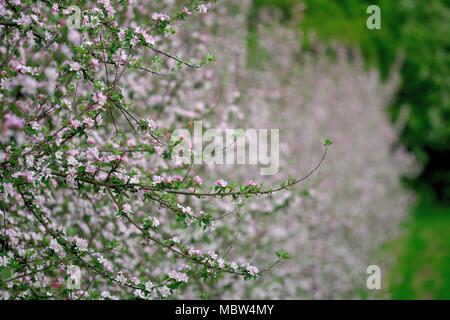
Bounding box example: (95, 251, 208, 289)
(248, 0, 450, 202)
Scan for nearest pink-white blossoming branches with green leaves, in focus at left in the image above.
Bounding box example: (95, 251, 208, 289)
(0, 0, 329, 299)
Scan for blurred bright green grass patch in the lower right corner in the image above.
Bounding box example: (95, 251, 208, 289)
(389, 192, 450, 299)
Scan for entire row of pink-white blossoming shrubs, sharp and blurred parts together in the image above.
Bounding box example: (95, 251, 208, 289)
(0, 0, 411, 299)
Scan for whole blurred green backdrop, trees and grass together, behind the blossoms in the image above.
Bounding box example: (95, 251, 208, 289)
(248, 0, 450, 299)
